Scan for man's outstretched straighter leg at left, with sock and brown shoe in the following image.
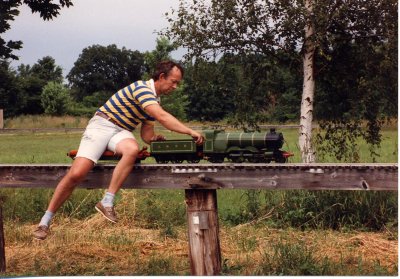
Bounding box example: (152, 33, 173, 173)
(33, 157, 94, 240)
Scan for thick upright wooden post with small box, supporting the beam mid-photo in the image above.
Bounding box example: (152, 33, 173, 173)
(185, 189, 221, 276)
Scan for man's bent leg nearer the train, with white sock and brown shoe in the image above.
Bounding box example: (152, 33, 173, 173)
(96, 138, 139, 223)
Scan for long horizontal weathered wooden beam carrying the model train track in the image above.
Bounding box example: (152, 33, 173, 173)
(0, 164, 398, 191)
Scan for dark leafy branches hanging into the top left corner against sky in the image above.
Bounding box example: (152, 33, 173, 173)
(0, 0, 73, 60)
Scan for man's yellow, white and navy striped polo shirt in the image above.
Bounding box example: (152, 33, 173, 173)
(97, 79, 158, 131)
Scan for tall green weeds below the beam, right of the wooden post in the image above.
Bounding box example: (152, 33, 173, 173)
(220, 190, 398, 232)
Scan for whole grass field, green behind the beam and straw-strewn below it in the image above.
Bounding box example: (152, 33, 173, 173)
(0, 117, 398, 276)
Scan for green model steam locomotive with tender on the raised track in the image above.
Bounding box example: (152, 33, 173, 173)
(68, 128, 293, 164)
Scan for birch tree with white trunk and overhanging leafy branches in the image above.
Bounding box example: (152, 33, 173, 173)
(164, 0, 397, 162)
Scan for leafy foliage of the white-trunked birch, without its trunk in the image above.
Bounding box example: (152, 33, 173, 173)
(162, 0, 398, 162)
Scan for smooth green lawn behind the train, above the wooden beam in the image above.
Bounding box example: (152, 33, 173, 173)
(0, 126, 398, 164)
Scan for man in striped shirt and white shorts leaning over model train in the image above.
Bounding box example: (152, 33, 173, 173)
(33, 61, 204, 240)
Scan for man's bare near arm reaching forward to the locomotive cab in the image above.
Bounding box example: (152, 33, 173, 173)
(144, 104, 204, 144)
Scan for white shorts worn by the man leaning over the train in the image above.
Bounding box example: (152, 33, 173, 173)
(76, 115, 136, 164)
